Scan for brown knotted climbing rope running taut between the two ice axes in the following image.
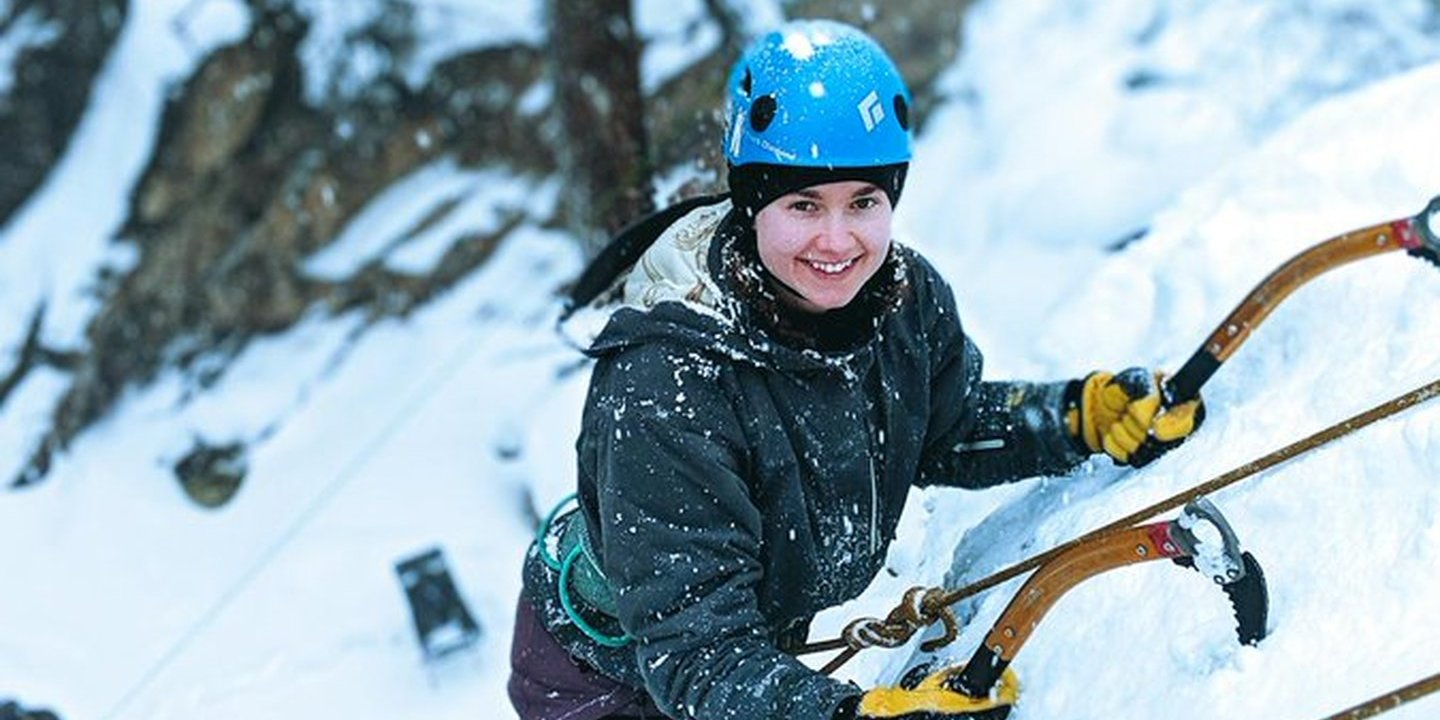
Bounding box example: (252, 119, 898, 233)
(795, 379, 1440, 675)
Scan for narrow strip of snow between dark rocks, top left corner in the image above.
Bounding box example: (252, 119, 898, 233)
(0, 0, 248, 351)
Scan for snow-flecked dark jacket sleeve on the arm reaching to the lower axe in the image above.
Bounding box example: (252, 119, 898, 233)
(582, 346, 860, 720)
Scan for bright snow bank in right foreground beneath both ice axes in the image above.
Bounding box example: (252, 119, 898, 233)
(846, 59, 1440, 719)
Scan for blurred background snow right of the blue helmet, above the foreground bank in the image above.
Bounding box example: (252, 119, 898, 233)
(897, 0, 1440, 376)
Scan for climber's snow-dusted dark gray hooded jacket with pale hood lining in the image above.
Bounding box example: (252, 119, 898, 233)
(527, 200, 1083, 720)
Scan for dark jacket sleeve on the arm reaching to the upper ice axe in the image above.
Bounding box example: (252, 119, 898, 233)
(917, 264, 1087, 488)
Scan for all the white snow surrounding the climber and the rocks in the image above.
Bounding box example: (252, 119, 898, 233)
(0, 0, 1440, 720)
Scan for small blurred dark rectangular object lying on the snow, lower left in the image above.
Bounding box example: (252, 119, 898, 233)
(395, 547, 481, 662)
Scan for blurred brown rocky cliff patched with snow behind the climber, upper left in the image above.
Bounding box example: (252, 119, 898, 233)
(0, 0, 962, 485)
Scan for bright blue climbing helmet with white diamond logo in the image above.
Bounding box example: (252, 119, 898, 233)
(724, 20, 910, 168)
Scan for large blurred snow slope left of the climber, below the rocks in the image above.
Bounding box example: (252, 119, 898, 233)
(0, 220, 577, 719)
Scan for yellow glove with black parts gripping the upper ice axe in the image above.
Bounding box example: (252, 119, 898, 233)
(1066, 367, 1205, 468)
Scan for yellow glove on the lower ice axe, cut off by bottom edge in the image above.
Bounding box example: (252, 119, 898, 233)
(834, 665, 1020, 720)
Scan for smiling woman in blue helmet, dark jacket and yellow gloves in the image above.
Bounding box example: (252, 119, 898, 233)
(510, 16, 1202, 720)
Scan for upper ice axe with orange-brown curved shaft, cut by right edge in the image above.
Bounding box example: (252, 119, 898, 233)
(1162, 196, 1440, 408)
